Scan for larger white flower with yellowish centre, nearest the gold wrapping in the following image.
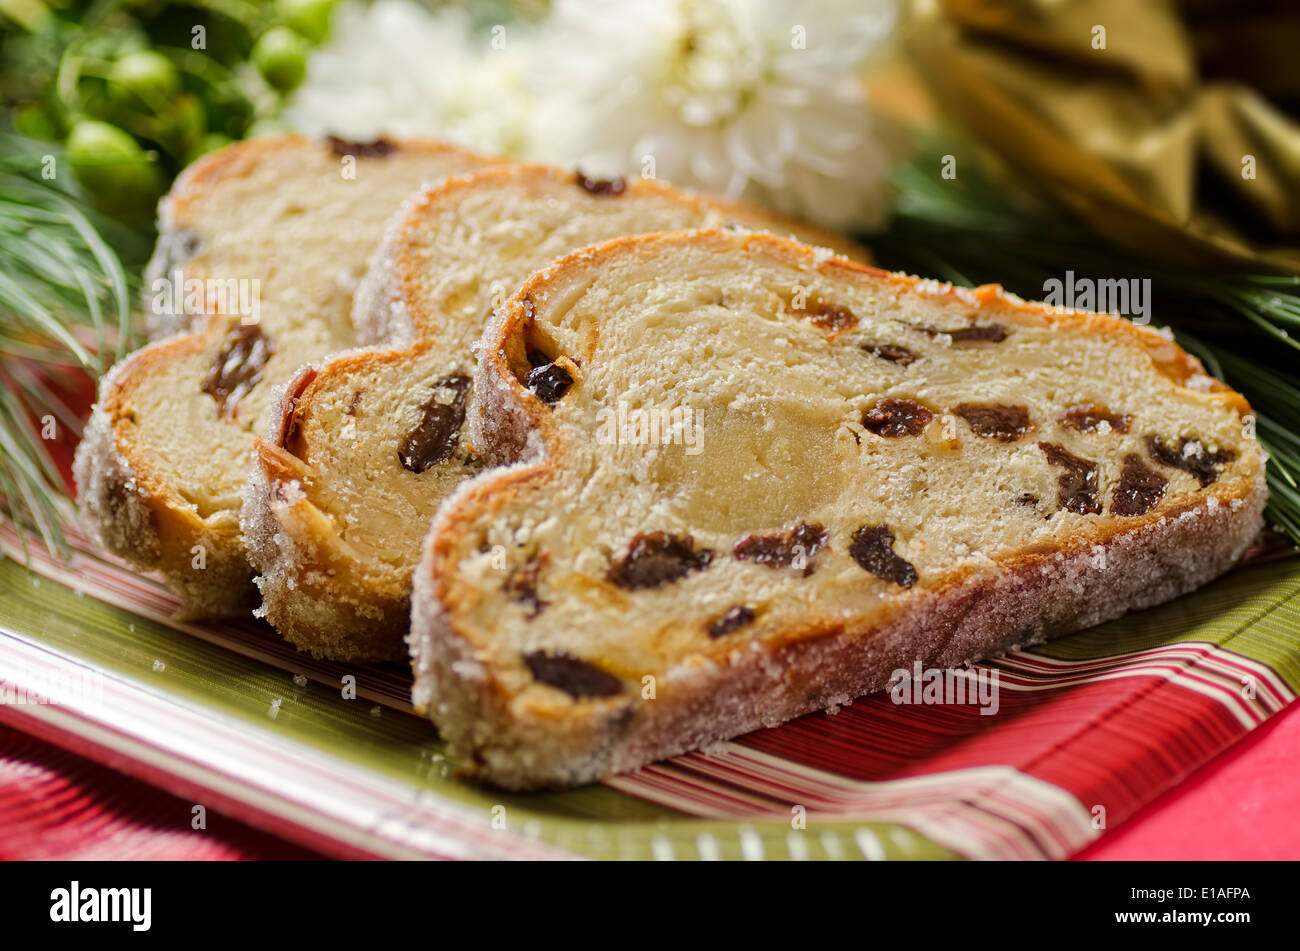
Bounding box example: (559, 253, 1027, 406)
(529, 0, 896, 227)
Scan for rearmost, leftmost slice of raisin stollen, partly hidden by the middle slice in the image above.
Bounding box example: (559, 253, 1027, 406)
(74, 136, 490, 617)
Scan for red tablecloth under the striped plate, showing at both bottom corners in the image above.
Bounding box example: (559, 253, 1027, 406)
(0, 703, 1300, 860)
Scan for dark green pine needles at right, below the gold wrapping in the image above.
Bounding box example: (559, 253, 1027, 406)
(871, 143, 1300, 543)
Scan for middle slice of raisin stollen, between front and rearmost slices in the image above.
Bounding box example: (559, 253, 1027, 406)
(244, 166, 863, 661)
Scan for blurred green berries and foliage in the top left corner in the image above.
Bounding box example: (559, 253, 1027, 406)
(0, 0, 335, 225)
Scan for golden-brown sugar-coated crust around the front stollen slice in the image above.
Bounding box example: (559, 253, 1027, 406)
(411, 231, 1266, 789)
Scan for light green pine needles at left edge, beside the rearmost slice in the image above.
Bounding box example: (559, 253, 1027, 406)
(0, 135, 151, 553)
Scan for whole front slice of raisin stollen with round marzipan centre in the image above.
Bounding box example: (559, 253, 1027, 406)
(411, 231, 1266, 789)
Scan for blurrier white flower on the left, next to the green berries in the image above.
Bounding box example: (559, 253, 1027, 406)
(285, 0, 532, 156)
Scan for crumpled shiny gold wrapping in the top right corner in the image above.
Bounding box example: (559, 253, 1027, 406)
(907, 0, 1300, 272)
